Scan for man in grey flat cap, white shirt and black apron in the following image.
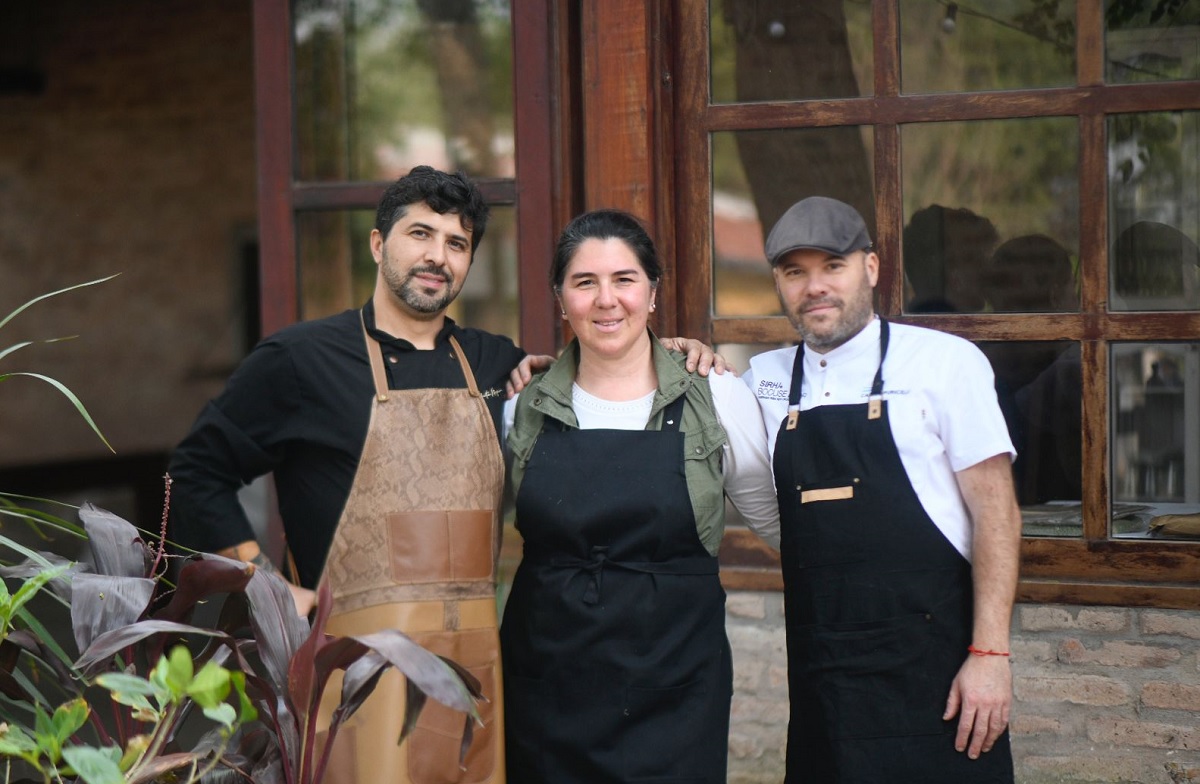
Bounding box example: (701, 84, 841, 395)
(745, 197, 1021, 784)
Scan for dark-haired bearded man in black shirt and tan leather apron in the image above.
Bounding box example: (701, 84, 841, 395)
(169, 166, 713, 784)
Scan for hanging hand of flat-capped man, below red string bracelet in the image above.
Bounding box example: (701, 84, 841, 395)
(942, 656, 1013, 760)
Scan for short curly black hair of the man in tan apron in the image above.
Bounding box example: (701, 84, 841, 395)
(376, 166, 487, 253)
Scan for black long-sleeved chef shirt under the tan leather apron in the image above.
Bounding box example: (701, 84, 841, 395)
(168, 301, 524, 587)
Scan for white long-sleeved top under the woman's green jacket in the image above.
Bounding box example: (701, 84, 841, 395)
(504, 372, 779, 547)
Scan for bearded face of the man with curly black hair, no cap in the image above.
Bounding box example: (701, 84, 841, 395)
(371, 203, 470, 318)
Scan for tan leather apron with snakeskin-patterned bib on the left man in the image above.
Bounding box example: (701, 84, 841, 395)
(318, 321, 504, 784)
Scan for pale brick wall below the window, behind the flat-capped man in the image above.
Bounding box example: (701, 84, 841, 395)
(726, 592, 1200, 784)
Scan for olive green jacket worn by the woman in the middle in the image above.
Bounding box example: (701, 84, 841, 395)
(509, 335, 727, 556)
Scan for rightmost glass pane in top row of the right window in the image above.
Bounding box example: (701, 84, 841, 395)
(1104, 1, 1200, 84)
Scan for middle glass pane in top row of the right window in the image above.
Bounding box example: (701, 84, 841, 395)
(900, 0, 1075, 94)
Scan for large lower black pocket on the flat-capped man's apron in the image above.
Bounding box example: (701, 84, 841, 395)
(788, 615, 954, 740)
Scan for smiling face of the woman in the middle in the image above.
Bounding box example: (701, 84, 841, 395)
(558, 238, 655, 358)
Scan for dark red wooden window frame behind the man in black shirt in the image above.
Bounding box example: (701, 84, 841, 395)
(253, 0, 572, 353)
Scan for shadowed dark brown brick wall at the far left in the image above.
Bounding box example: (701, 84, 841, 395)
(0, 0, 257, 470)
